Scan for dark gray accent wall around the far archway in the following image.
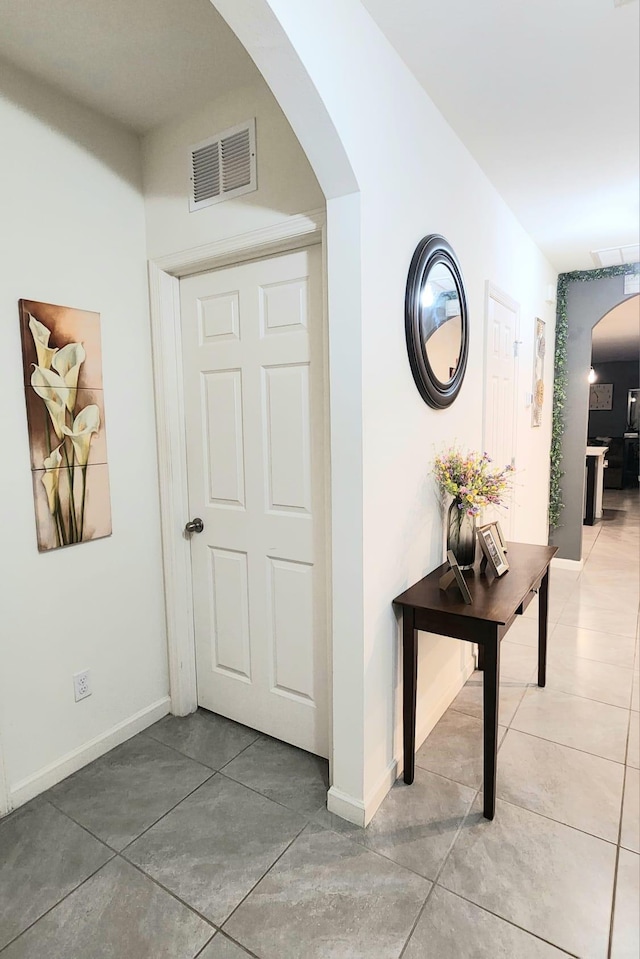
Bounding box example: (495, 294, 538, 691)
(549, 276, 627, 560)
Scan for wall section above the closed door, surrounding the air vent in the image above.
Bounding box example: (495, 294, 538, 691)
(143, 83, 324, 259)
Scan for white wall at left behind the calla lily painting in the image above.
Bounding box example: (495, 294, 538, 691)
(0, 64, 168, 803)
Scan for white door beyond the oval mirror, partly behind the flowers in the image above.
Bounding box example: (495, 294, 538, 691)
(483, 287, 519, 538)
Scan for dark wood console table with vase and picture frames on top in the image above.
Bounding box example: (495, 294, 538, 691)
(394, 543, 557, 819)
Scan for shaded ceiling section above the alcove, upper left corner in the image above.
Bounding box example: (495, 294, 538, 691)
(0, 0, 260, 133)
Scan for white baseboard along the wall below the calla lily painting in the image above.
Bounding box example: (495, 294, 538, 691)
(9, 696, 171, 809)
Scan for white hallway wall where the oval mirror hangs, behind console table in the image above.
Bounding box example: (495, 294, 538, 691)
(213, 0, 555, 818)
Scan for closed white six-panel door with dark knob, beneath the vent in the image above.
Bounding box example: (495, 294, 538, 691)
(180, 247, 329, 757)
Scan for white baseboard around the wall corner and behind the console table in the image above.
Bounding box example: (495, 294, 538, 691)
(327, 657, 475, 826)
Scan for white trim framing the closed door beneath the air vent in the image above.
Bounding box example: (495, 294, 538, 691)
(148, 209, 324, 720)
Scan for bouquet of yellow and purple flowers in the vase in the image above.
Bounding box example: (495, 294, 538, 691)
(433, 447, 514, 516)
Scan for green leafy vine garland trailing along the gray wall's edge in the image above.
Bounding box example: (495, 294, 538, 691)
(549, 263, 640, 529)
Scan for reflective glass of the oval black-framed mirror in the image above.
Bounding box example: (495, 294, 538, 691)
(420, 262, 462, 384)
